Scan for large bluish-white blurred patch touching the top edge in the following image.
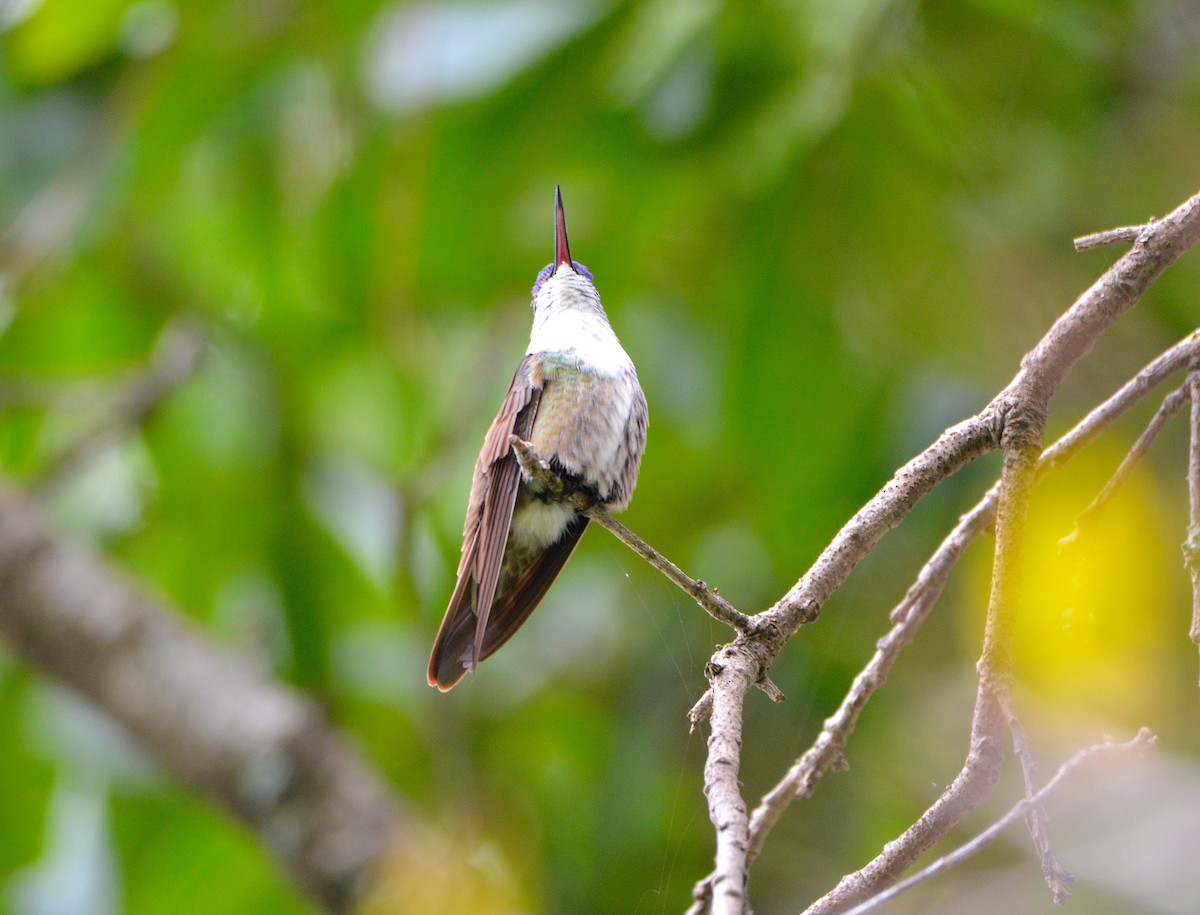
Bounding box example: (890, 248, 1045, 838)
(364, 0, 604, 113)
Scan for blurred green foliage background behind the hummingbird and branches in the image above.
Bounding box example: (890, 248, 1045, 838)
(0, 0, 1200, 915)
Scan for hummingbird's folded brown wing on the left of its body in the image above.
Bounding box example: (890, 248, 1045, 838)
(426, 357, 542, 690)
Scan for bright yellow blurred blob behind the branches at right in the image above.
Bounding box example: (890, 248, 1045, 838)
(979, 447, 1171, 722)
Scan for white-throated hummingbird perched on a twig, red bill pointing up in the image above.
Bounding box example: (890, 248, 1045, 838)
(426, 189, 648, 692)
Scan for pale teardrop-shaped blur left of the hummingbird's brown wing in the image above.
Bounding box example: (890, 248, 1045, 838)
(304, 460, 401, 590)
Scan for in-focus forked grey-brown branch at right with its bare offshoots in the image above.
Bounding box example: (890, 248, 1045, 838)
(689, 195, 1200, 913)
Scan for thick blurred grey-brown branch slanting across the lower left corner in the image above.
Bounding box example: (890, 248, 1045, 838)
(0, 488, 409, 913)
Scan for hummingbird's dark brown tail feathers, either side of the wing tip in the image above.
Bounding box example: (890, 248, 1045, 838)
(426, 518, 588, 693)
